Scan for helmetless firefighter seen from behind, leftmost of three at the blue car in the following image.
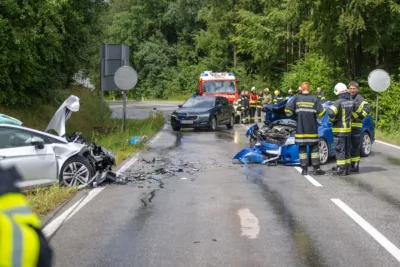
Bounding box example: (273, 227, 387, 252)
(285, 82, 325, 175)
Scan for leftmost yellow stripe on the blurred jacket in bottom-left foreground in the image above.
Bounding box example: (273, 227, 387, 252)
(0, 213, 14, 267)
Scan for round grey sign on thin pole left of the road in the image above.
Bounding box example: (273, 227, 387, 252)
(114, 66, 138, 132)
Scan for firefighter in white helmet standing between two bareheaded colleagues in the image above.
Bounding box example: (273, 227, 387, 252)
(328, 83, 355, 175)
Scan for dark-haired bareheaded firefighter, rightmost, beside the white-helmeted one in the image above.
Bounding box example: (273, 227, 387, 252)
(348, 81, 371, 172)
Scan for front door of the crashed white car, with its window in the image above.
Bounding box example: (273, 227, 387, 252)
(0, 125, 58, 185)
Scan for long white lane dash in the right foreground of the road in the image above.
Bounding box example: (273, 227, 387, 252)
(331, 198, 400, 262)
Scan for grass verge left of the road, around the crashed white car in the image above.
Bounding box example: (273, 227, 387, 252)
(0, 87, 165, 216)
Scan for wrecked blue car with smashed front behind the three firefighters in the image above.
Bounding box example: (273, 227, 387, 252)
(233, 99, 375, 165)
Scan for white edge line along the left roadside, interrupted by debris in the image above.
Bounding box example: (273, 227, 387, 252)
(43, 125, 166, 238)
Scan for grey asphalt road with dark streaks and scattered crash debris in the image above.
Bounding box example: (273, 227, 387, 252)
(50, 103, 400, 267)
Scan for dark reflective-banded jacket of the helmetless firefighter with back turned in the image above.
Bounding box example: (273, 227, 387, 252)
(285, 94, 326, 145)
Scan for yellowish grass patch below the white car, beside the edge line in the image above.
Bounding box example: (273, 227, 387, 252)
(25, 185, 78, 218)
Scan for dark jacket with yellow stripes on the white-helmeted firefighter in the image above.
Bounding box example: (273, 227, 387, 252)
(328, 93, 355, 136)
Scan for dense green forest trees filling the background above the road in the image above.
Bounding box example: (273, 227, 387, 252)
(0, 0, 400, 130)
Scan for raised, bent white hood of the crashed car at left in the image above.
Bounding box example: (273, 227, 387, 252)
(45, 95, 80, 137)
